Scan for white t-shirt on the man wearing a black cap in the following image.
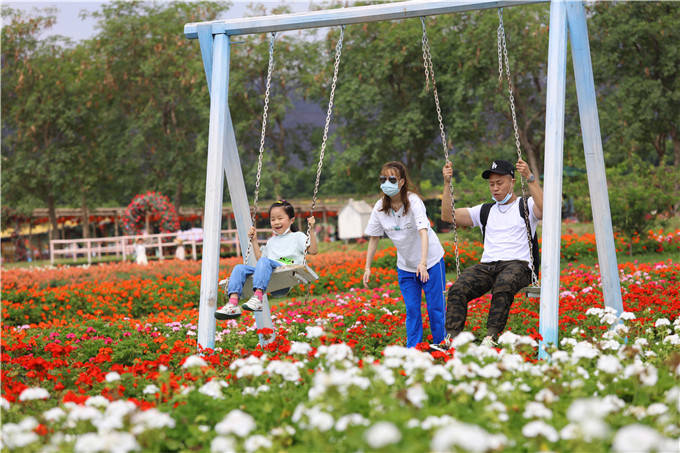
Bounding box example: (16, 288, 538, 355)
(468, 197, 539, 267)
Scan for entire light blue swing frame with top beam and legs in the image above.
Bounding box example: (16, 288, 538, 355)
(184, 0, 623, 358)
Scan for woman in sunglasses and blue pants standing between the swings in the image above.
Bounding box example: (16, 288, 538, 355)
(363, 162, 446, 348)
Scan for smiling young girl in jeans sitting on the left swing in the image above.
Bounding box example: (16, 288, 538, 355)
(215, 200, 318, 319)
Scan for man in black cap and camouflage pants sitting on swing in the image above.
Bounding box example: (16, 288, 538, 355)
(438, 159, 543, 350)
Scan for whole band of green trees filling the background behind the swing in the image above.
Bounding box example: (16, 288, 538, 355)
(2, 1, 680, 221)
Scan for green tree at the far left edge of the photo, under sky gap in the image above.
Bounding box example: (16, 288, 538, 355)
(2, 8, 72, 240)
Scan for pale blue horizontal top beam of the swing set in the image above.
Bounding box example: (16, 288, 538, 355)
(184, 0, 549, 39)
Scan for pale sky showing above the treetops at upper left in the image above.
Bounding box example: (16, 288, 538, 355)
(2, 0, 319, 41)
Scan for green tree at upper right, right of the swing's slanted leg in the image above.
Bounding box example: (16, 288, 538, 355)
(590, 2, 680, 166)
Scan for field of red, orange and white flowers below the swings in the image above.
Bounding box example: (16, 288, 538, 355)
(0, 232, 680, 452)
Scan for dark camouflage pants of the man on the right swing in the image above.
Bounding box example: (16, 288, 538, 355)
(446, 260, 531, 336)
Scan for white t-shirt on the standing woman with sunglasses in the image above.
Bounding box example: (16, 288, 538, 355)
(365, 193, 444, 272)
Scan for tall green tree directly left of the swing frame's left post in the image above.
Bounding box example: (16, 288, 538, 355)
(81, 1, 228, 209)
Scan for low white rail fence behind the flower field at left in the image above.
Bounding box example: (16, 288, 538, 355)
(50, 229, 266, 264)
